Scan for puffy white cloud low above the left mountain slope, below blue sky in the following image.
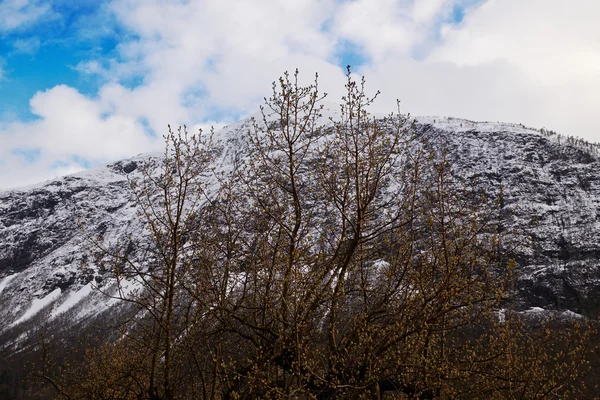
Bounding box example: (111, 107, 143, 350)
(0, 85, 160, 187)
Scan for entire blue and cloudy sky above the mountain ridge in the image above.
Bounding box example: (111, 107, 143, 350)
(0, 0, 600, 189)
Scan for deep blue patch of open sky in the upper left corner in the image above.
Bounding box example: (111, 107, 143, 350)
(0, 0, 119, 121)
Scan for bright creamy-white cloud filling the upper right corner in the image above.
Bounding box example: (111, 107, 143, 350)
(431, 0, 600, 85)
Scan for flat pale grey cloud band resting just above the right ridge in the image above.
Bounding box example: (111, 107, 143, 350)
(361, 60, 600, 134)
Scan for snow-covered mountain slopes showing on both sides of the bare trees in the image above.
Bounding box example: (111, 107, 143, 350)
(0, 117, 600, 351)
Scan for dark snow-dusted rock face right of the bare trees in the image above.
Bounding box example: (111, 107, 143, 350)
(414, 120, 600, 317)
